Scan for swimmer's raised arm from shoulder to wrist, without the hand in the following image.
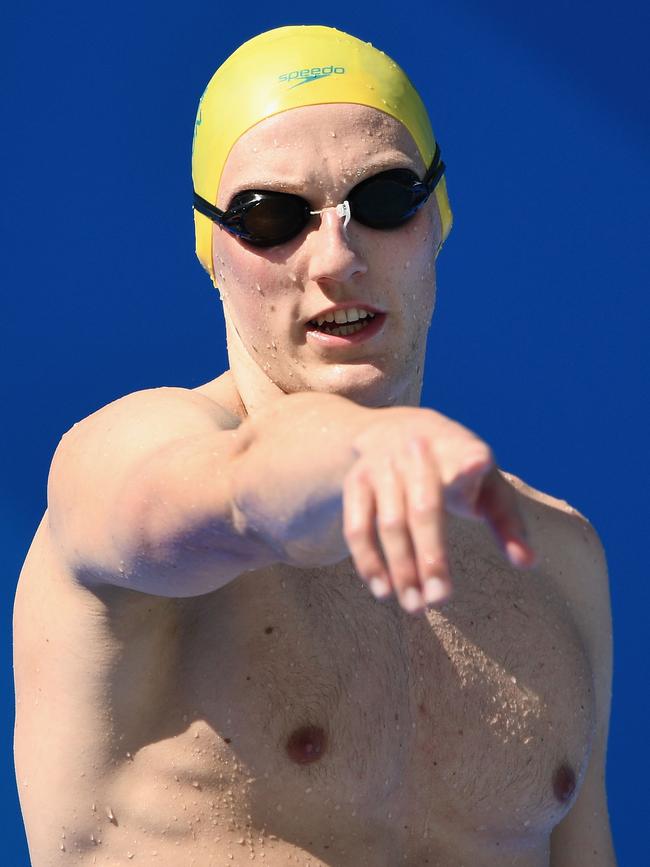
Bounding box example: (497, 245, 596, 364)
(48, 388, 371, 596)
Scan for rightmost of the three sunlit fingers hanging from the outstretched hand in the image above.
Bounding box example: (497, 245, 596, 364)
(406, 437, 452, 604)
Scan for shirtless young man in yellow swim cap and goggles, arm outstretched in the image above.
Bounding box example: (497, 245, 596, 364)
(15, 27, 615, 867)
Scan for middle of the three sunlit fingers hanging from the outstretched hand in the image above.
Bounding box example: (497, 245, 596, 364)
(375, 458, 425, 612)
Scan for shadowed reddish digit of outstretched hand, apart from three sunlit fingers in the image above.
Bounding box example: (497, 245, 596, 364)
(476, 467, 537, 569)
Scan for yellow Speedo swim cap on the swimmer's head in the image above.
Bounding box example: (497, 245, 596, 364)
(192, 26, 452, 283)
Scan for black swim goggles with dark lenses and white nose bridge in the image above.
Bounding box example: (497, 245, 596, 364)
(194, 145, 445, 247)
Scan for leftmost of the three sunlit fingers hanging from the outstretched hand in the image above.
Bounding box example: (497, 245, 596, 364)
(343, 470, 392, 599)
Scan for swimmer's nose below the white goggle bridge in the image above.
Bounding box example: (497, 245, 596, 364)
(309, 206, 368, 283)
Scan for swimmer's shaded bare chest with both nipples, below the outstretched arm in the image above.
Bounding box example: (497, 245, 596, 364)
(171, 524, 594, 840)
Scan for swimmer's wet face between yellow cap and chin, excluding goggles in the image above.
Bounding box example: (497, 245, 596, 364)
(212, 104, 440, 406)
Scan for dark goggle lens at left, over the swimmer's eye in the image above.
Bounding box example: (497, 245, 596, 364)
(230, 191, 309, 247)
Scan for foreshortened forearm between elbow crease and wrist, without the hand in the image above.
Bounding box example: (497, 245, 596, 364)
(233, 393, 374, 565)
